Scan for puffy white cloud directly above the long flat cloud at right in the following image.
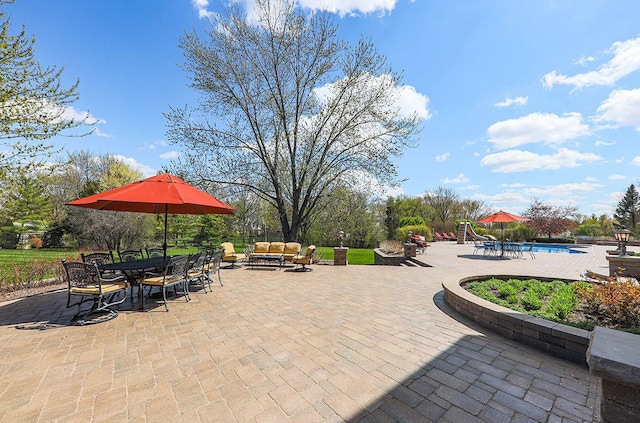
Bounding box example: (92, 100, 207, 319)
(487, 113, 590, 150)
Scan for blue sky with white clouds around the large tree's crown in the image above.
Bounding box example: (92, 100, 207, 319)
(5, 0, 640, 215)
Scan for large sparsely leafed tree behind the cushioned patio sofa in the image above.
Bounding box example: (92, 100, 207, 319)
(166, 0, 420, 240)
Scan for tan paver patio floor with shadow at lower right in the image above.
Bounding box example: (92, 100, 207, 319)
(0, 242, 608, 423)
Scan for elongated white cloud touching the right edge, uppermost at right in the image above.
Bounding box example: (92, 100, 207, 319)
(543, 37, 640, 90)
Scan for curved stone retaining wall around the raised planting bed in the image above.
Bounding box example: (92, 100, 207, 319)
(442, 275, 591, 367)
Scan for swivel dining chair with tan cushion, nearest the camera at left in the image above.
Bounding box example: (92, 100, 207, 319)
(62, 260, 128, 325)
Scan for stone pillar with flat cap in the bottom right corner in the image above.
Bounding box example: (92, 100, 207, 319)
(587, 326, 640, 423)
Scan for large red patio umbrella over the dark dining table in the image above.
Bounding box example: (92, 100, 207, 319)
(66, 173, 233, 257)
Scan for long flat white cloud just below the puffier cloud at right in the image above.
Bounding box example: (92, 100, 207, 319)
(480, 148, 604, 173)
